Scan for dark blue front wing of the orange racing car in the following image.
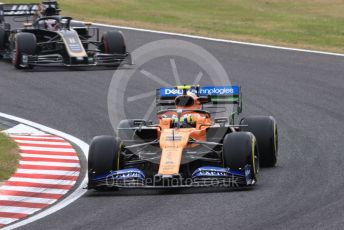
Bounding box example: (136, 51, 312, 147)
(87, 165, 256, 189)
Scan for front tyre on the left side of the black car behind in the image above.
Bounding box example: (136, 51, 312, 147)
(12, 33, 37, 69)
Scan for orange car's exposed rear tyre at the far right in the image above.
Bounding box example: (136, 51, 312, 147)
(240, 116, 278, 167)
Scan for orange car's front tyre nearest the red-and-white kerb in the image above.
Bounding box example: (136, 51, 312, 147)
(88, 136, 121, 191)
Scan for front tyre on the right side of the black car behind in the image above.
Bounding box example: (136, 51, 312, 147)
(100, 31, 127, 54)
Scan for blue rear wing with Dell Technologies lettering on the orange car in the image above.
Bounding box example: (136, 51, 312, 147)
(156, 85, 242, 113)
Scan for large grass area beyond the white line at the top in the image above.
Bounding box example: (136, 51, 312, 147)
(2, 0, 344, 52)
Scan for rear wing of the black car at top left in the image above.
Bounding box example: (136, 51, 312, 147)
(0, 1, 60, 17)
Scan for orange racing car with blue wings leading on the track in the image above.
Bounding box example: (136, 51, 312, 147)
(88, 86, 278, 190)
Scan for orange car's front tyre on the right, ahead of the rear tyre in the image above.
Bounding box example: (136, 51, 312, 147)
(222, 132, 259, 179)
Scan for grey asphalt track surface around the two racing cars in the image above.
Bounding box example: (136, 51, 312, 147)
(0, 24, 344, 230)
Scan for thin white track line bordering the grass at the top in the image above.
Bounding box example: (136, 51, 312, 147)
(93, 23, 344, 57)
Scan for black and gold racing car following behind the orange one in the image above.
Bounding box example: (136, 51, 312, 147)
(0, 1, 131, 69)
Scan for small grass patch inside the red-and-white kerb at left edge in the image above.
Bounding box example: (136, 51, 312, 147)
(0, 133, 19, 182)
